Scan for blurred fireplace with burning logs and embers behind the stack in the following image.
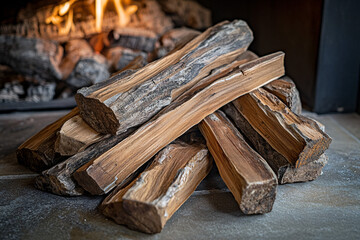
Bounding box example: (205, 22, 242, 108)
(0, 0, 211, 111)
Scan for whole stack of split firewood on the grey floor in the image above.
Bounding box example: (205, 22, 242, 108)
(17, 21, 331, 233)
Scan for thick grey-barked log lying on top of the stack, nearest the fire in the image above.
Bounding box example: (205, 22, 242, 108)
(75, 21, 253, 134)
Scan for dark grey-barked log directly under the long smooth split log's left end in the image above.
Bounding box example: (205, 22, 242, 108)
(35, 128, 134, 196)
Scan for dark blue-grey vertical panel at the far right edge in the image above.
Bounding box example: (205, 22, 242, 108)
(314, 0, 360, 113)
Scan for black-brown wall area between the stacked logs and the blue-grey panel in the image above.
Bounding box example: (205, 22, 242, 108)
(200, 0, 323, 108)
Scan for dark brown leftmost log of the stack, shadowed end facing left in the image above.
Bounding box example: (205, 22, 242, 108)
(16, 108, 79, 172)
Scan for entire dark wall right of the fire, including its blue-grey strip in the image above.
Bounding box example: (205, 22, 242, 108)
(200, 0, 360, 113)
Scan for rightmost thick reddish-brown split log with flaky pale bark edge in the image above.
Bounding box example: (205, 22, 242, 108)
(223, 89, 331, 184)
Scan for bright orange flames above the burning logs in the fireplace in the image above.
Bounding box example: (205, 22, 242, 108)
(45, 0, 138, 35)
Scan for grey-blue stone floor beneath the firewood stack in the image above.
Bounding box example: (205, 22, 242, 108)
(0, 111, 360, 239)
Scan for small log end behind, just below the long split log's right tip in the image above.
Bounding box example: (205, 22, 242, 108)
(264, 77, 302, 115)
